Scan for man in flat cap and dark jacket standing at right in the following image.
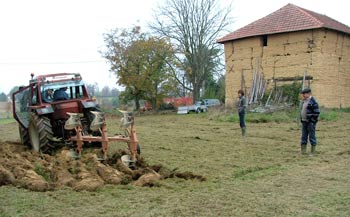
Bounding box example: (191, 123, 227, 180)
(300, 88, 320, 157)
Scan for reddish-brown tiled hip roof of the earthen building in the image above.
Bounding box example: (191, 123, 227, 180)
(217, 4, 350, 43)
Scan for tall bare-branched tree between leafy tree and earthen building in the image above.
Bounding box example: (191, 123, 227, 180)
(150, 0, 231, 100)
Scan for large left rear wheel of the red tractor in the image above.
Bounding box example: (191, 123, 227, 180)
(28, 113, 54, 153)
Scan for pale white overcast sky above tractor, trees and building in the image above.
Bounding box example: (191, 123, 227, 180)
(0, 0, 350, 94)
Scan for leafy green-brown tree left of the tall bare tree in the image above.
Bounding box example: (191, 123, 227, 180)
(102, 27, 173, 109)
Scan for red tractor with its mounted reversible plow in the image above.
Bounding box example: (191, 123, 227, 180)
(12, 73, 139, 161)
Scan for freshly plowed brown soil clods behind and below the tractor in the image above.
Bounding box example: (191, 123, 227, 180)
(0, 141, 205, 191)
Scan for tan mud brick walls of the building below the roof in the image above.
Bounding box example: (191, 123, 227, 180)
(224, 29, 350, 108)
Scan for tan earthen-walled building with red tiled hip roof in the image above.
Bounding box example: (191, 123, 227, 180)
(218, 4, 350, 108)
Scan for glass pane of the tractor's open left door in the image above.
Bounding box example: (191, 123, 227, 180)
(13, 86, 31, 128)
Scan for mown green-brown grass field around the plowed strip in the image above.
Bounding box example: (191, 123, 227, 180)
(0, 109, 350, 217)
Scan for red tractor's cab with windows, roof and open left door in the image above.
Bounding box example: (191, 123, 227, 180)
(13, 73, 97, 128)
